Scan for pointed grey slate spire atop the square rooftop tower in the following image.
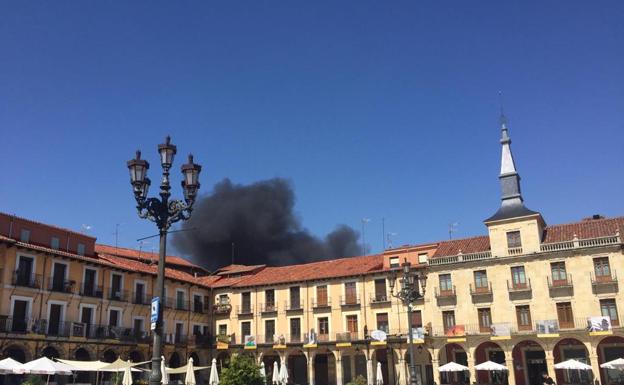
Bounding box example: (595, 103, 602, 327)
(485, 109, 539, 222)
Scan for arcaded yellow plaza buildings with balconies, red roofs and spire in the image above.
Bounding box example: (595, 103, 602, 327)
(0, 117, 624, 385)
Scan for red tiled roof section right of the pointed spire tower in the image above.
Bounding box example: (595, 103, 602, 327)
(543, 217, 624, 243)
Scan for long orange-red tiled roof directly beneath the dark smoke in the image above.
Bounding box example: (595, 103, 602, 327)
(235, 255, 383, 287)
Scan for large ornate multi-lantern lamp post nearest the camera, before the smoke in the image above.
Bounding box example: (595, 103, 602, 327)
(128, 136, 201, 385)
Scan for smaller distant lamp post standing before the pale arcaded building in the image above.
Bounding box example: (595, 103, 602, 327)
(390, 258, 427, 385)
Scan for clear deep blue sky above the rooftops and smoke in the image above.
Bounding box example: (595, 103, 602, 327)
(0, 1, 624, 251)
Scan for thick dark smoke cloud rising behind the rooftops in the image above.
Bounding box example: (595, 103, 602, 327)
(173, 178, 362, 270)
